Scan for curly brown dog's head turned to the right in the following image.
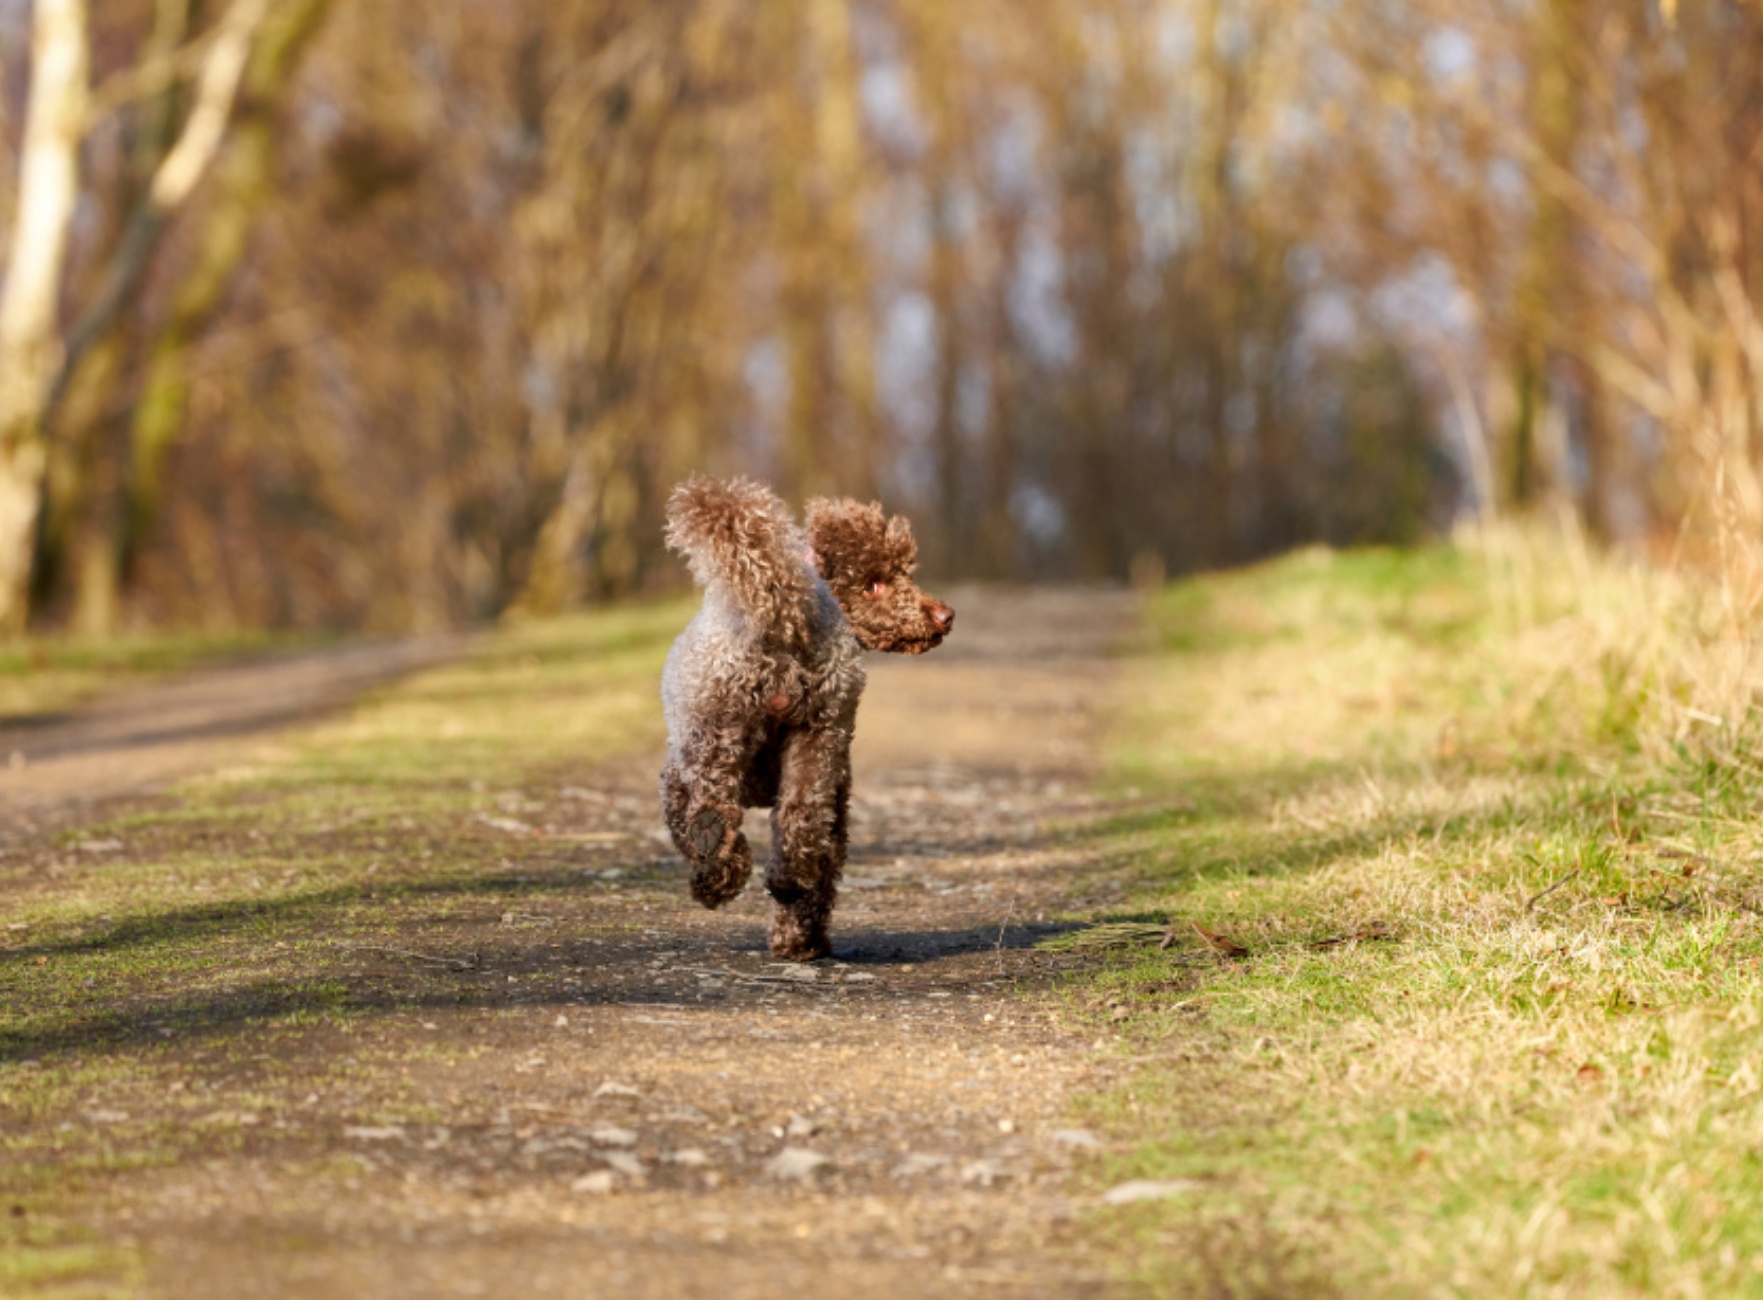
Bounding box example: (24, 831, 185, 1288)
(807, 497, 956, 654)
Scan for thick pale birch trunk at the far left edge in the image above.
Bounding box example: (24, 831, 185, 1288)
(0, 0, 88, 635)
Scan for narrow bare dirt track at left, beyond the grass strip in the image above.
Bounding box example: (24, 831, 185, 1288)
(0, 637, 469, 843)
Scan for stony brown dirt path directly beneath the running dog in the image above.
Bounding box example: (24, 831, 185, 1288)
(6, 593, 1130, 1300)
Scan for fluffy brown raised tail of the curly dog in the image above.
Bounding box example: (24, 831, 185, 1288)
(666, 474, 815, 642)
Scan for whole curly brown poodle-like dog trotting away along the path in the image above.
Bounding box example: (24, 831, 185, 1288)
(661, 476, 956, 961)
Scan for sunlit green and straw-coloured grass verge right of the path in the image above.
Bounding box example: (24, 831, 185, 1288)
(1070, 536, 1763, 1296)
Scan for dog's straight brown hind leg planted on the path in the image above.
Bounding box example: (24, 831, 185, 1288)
(765, 728, 852, 961)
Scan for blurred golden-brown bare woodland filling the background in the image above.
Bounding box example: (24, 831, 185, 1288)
(0, 0, 1763, 631)
